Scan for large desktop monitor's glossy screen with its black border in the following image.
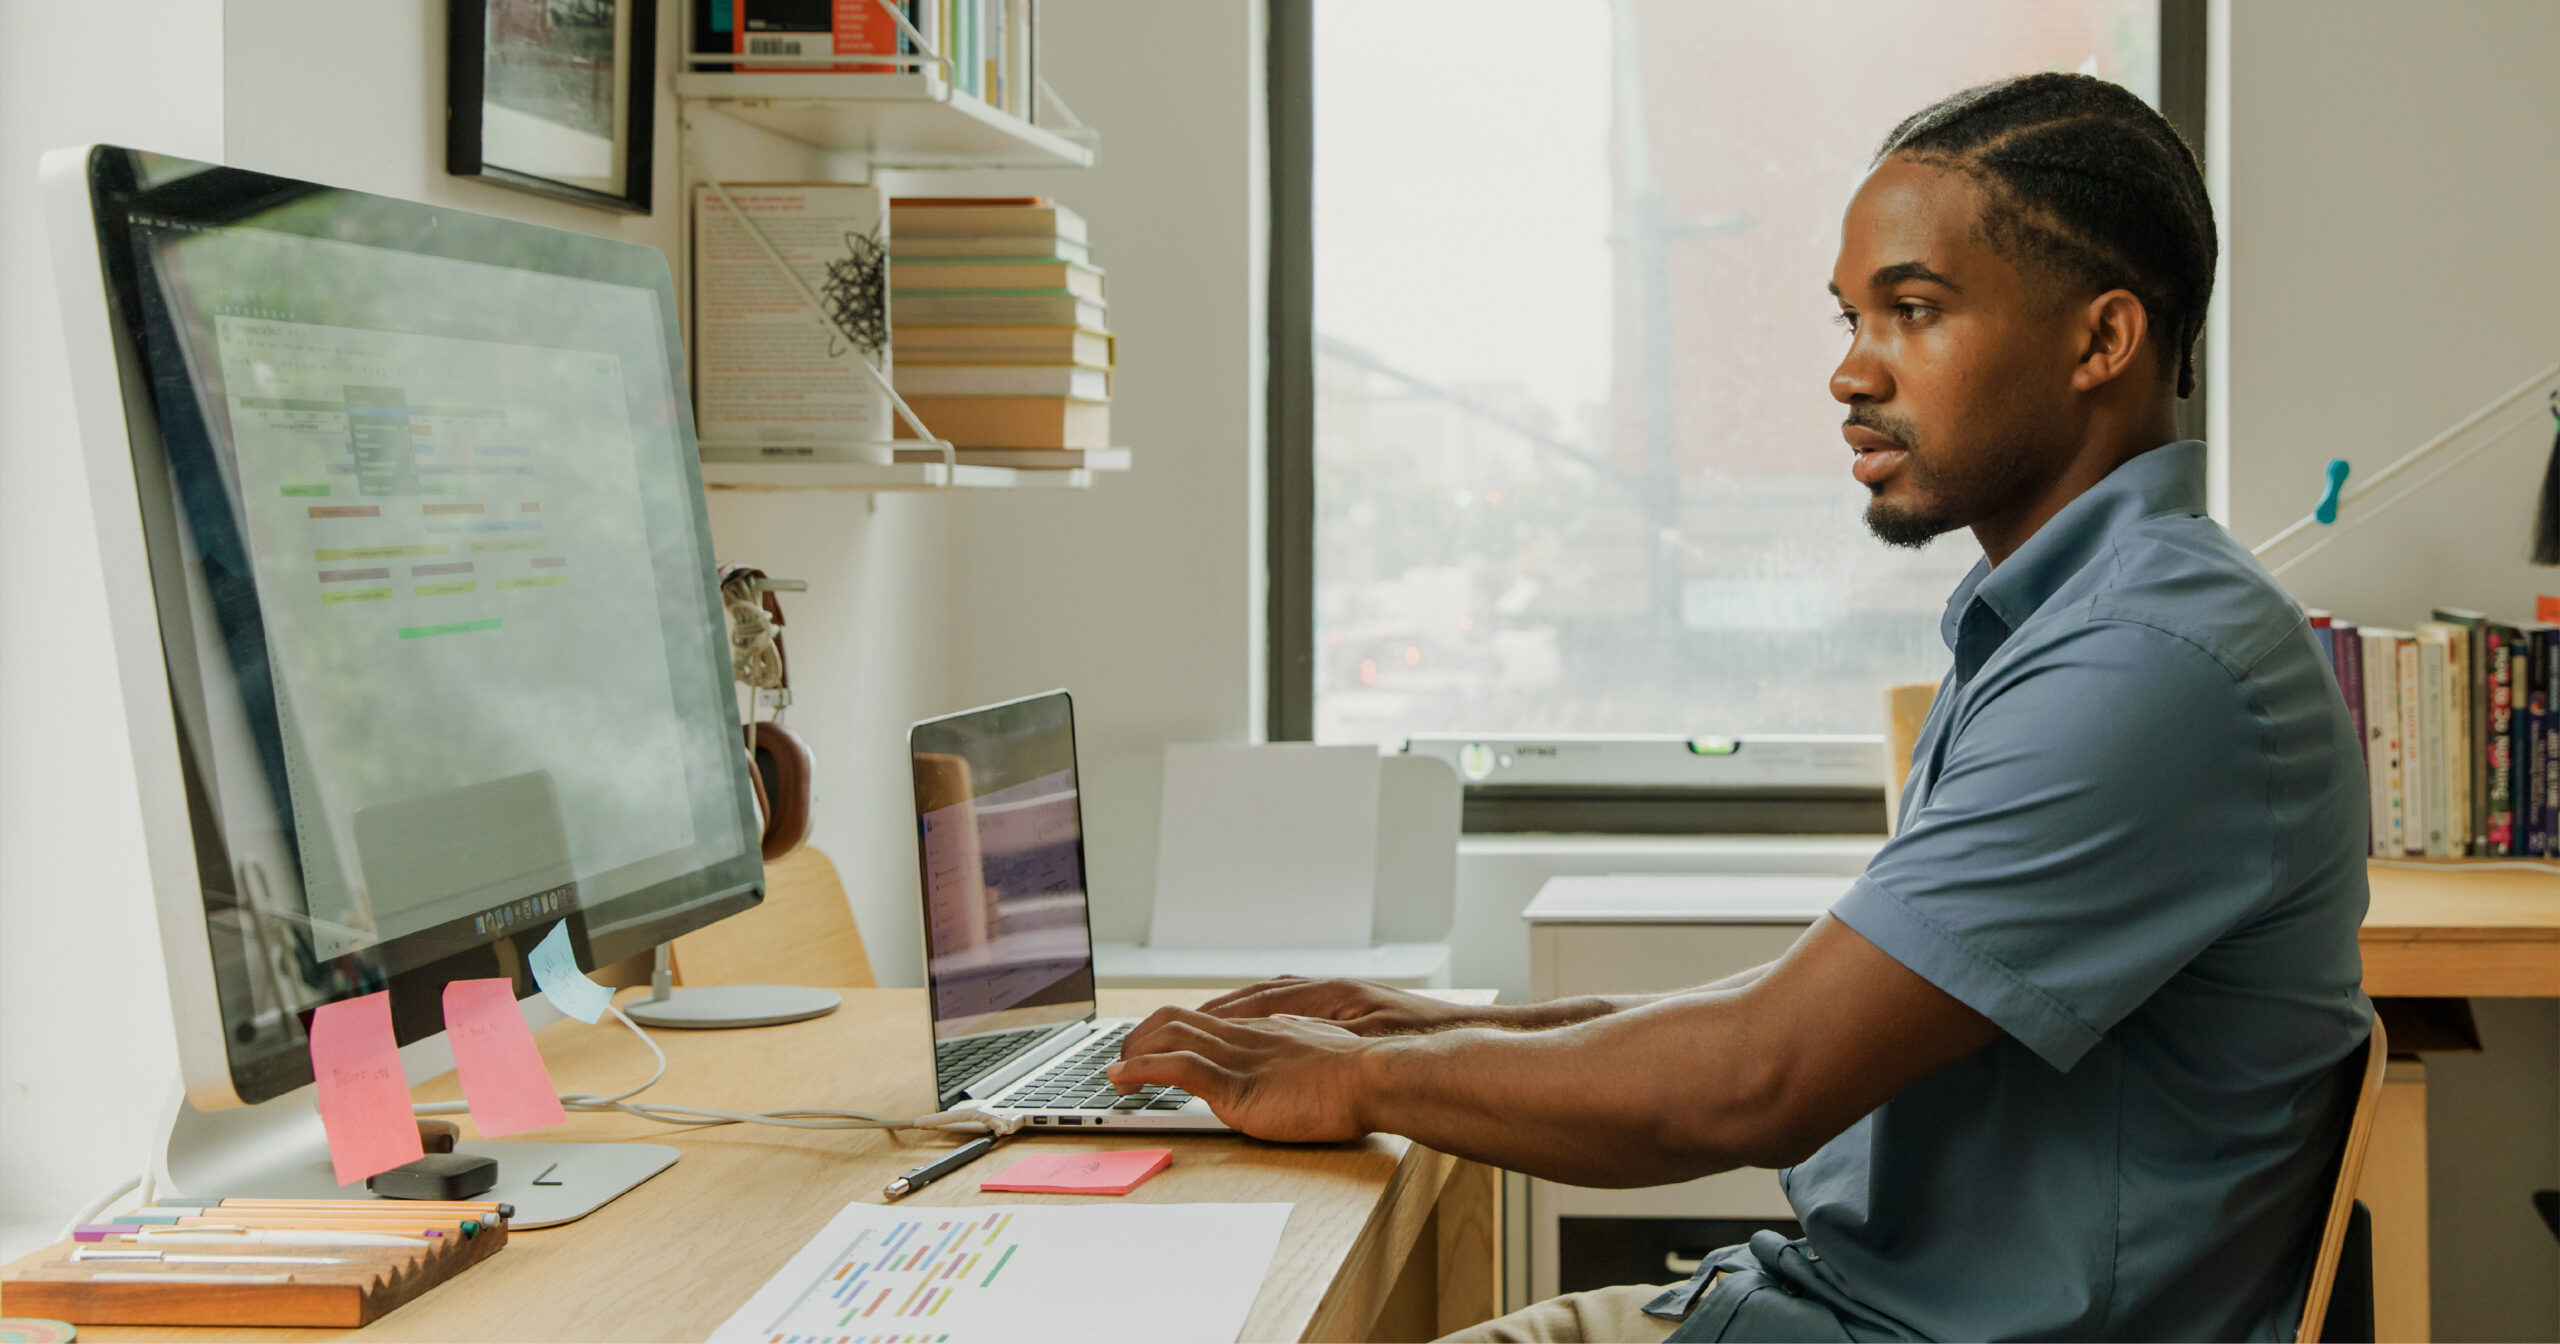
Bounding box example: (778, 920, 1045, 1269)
(74, 148, 763, 1101)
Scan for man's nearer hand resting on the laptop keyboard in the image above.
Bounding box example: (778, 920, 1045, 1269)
(1111, 1009, 1372, 1144)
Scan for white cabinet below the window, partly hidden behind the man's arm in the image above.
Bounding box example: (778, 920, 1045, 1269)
(1521, 870, 1856, 1300)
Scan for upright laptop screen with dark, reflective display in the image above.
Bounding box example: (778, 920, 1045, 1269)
(909, 691, 1093, 1055)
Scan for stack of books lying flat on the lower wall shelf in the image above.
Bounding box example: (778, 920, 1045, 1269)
(888, 197, 1126, 468)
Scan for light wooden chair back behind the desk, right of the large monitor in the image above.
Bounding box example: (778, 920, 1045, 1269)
(673, 845, 881, 988)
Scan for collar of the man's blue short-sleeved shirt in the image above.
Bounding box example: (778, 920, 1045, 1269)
(1938, 438, 2204, 648)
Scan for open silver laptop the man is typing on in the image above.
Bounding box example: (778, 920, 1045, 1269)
(906, 691, 1226, 1132)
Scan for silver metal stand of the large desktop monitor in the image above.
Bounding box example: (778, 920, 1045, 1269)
(151, 1088, 681, 1231)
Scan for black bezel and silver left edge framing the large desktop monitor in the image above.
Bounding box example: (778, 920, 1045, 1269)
(41, 146, 765, 1108)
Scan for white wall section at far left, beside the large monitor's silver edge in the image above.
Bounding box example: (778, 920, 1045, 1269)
(0, 0, 223, 1254)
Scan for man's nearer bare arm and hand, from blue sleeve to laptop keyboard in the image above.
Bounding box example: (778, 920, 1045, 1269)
(1111, 916, 1999, 1185)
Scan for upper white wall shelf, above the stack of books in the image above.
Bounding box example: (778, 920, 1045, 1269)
(676, 69, 1093, 169)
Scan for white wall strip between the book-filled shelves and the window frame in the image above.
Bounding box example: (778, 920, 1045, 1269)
(926, 0, 1270, 940)
